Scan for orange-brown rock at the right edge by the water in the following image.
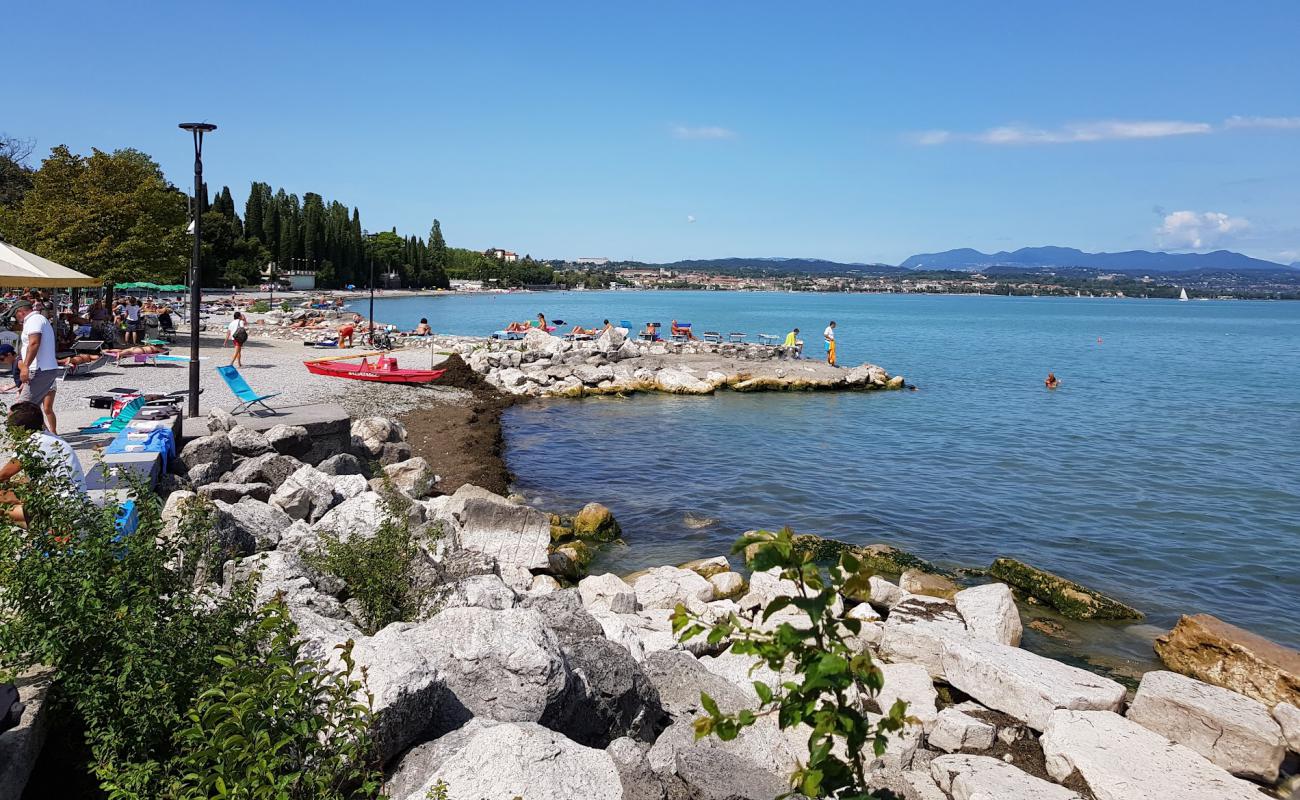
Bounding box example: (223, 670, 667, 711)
(1156, 614, 1300, 706)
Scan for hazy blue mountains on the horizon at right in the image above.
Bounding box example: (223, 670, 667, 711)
(901, 247, 1294, 272)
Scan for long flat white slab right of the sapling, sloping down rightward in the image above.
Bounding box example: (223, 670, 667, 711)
(935, 626, 1125, 731)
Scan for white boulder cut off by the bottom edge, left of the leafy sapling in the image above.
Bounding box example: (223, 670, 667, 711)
(390, 721, 624, 800)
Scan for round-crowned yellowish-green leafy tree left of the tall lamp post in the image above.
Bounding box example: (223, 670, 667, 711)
(5, 144, 191, 282)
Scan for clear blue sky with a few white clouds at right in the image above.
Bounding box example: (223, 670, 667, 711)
(10, 0, 1300, 263)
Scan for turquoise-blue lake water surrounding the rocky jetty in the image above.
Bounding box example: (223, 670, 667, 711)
(376, 291, 1300, 652)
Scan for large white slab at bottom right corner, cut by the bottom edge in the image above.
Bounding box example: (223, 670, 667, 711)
(1040, 709, 1261, 800)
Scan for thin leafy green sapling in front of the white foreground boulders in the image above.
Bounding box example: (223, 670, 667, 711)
(672, 528, 907, 800)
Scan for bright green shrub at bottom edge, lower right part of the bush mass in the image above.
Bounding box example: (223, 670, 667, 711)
(166, 598, 382, 800)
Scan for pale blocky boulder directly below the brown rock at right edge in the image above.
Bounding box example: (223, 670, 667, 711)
(1128, 670, 1286, 783)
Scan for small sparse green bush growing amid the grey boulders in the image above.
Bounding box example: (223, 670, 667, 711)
(306, 488, 429, 633)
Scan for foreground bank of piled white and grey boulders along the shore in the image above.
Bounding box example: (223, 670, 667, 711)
(165, 419, 1296, 800)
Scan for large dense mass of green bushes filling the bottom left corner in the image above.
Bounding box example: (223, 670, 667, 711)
(0, 437, 377, 800)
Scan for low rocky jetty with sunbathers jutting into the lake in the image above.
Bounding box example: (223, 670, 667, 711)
(445, 328, 905, 397)
